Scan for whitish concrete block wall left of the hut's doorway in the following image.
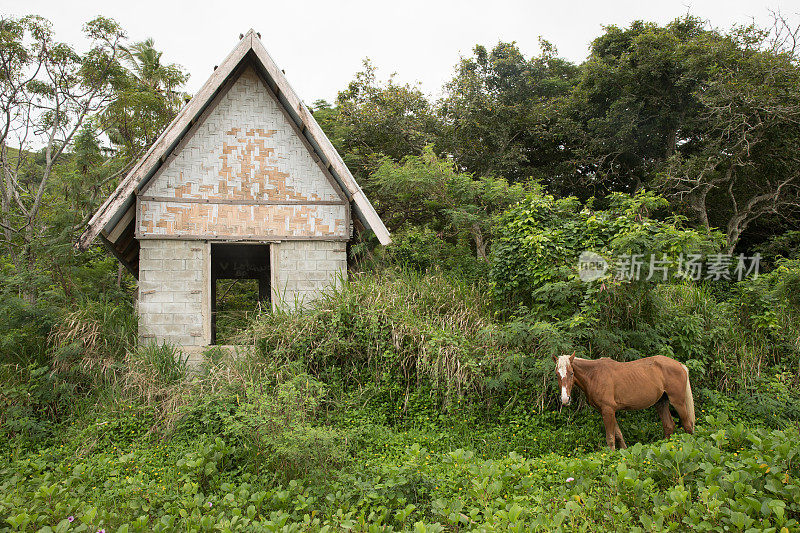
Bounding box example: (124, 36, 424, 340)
(138, 239, 211, 346)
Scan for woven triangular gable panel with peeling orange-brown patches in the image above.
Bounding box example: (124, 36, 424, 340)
(137, 68, 349, 238)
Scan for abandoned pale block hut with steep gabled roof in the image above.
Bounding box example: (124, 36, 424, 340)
(77, 30, 390, 348)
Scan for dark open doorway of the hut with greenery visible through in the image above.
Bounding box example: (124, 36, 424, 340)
(211, 243, 271, 344)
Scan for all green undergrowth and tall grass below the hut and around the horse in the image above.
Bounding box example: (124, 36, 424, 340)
(0, 270, 800, 532)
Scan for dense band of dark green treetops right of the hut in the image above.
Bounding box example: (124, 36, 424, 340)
(318, 16, 800, 252)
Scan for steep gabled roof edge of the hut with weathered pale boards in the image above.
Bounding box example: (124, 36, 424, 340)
(76, 29, 391, 271)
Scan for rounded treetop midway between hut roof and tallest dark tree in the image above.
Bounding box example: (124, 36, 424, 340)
(439, 40, 579, 181)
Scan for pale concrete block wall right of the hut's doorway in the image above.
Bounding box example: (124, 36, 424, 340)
(272, 241, 347, 309)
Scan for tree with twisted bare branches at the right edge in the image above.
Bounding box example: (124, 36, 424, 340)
(660, 15, 800, 252)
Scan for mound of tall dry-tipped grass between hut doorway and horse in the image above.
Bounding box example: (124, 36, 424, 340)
(248, 269, 509, 405)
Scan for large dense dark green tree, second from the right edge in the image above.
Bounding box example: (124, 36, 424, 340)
(570, 17, 711, 192)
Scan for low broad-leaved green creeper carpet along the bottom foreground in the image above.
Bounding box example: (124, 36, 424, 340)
(0, 382, 800, 531)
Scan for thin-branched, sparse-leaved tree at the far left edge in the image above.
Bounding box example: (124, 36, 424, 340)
(0, 16, 125, 286)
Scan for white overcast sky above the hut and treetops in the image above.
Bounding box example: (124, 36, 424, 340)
(6, 0, 800, 103)
